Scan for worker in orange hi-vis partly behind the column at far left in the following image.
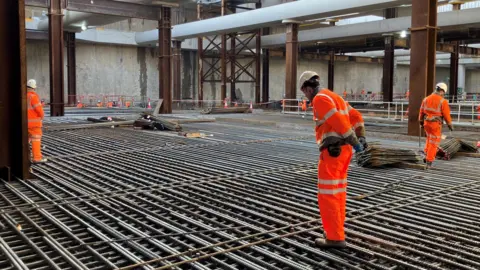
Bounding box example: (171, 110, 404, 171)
(27, 79, 47, 163)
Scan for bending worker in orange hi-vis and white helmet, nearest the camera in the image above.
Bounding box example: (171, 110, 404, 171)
(299, 71, 364, 248)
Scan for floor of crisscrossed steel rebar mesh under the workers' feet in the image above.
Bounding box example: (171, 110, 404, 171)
(0, 123, 480, 269)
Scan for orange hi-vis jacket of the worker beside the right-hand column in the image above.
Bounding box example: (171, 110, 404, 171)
(419, 93, 452, 125)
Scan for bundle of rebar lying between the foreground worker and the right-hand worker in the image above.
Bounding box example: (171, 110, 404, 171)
(356, 144, 422, 168)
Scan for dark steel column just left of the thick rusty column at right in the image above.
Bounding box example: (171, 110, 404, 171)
(382, 36, 395, 102)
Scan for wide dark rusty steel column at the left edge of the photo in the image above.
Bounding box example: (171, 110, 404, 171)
(0, 0, 30, 181)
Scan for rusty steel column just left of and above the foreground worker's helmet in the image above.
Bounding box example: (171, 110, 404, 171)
(285, 23, 298, 107)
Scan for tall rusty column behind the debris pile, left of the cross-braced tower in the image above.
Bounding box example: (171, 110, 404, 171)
(158, 7, 172, 113)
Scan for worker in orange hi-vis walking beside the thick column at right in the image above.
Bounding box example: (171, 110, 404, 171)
(419, 83, 453, 168)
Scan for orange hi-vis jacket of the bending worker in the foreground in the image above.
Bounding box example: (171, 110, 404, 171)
(312, 89, 356, 149)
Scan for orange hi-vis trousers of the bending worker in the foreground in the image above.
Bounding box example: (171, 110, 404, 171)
(317, 145, 352, 241)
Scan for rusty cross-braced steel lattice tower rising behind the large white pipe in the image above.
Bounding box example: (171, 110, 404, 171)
(197, 0, 260, 106)
